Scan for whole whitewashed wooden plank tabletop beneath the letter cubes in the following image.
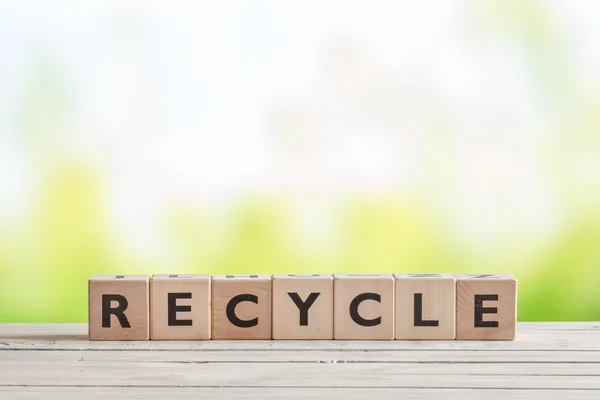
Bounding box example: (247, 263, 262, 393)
(0, 322, 600, 400)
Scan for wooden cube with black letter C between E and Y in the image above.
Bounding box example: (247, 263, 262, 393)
(212, 275, 271, 340)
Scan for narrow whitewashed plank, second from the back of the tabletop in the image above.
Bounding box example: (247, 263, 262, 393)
(0, 350, 600, 364)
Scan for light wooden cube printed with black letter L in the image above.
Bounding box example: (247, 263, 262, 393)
(394, 273, 456, 340)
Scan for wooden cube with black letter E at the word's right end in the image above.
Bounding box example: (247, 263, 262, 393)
(456, 274, 517, 340)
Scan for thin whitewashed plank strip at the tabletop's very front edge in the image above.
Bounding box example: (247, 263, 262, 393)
(0, 386, 600, 400)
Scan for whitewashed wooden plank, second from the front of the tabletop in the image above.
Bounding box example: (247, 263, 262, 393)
(0, 362, 600, 390)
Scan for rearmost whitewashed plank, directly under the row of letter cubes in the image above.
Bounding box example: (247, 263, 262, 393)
(0, 323, 600, 351)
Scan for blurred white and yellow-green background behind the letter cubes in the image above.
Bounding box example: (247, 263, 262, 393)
(0, 0, 600, 322)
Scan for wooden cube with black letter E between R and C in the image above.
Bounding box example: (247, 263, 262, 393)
(150, 274, 212, 340)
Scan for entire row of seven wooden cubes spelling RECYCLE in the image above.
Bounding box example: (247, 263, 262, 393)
(89, 273, 517, 340)
